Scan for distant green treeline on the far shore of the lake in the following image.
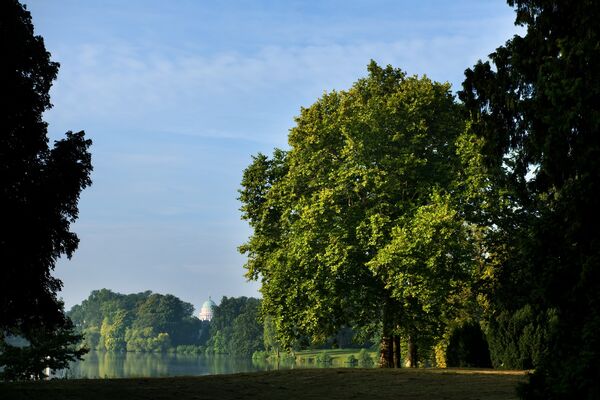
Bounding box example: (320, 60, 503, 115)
(67, 289, 264, 356)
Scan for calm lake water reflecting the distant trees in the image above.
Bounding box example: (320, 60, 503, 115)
(56, 351, 294, 378)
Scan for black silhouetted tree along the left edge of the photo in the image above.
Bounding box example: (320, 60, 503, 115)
(0, 0, 92, 376)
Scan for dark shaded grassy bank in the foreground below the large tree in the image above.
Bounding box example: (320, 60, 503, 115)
(0, 369, 526, 400)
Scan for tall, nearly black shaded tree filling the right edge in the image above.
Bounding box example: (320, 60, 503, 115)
(460, 0, 600, 399)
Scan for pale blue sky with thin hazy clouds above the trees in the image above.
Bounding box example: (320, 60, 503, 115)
(24, 0, 518, 310)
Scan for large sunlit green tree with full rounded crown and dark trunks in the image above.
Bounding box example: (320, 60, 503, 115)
(240, 62, 473, 366)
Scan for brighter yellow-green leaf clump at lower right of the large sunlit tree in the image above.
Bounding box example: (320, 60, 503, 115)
(367, 193, 476, 318)
